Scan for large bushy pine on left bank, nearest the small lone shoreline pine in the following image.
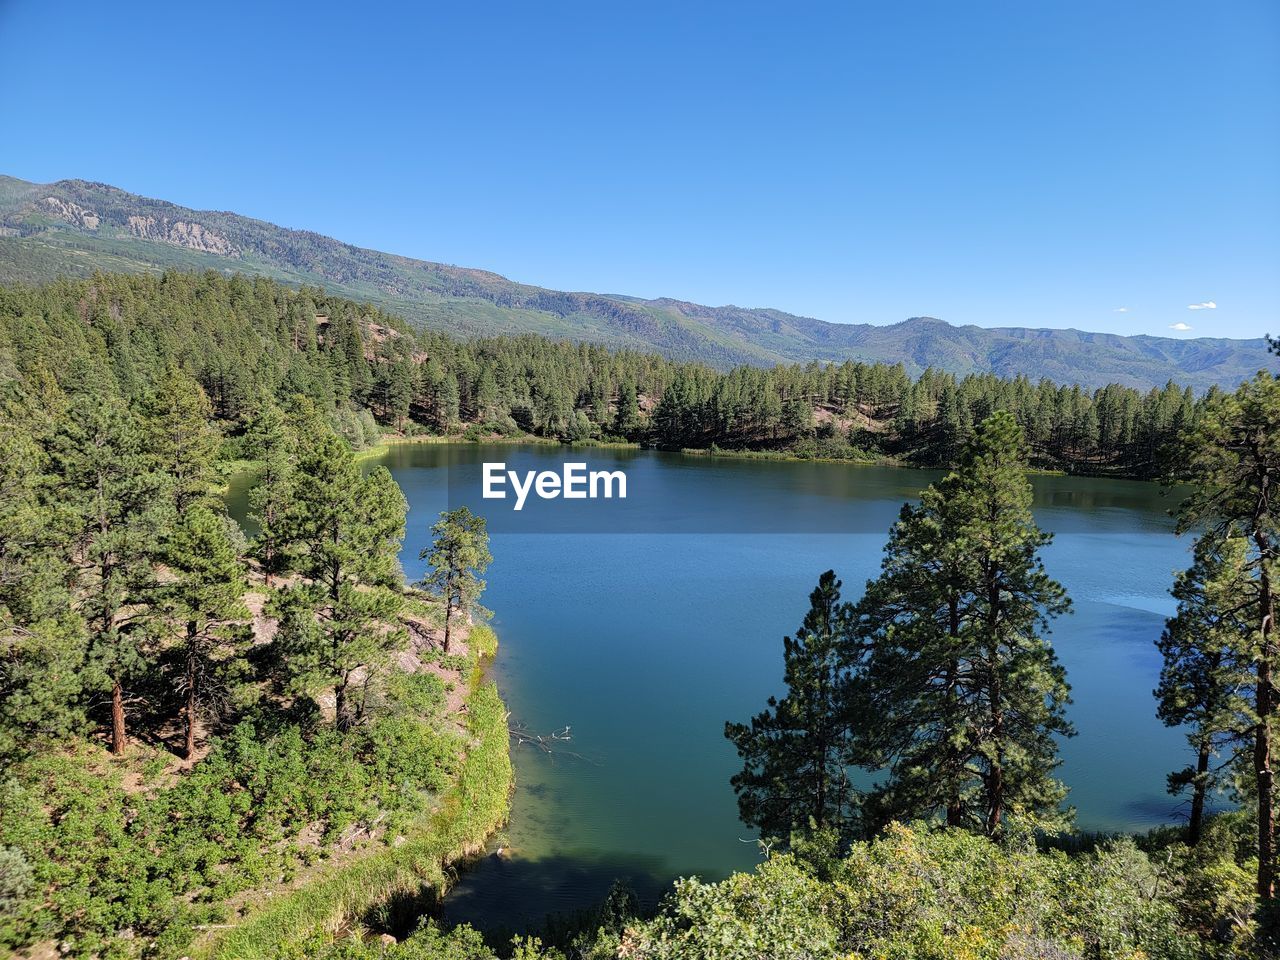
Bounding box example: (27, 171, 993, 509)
(273, 420, 407, 730)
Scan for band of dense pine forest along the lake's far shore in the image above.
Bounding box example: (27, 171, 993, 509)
(0, 271, 1219, 477)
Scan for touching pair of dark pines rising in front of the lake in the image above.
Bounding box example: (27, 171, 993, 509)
(726, 413, 1073, 840)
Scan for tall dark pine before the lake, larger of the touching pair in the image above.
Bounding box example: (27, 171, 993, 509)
(850, 412, 1073, 835)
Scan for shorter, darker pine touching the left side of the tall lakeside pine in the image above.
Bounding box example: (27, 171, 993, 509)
(724, 571, 856, 841)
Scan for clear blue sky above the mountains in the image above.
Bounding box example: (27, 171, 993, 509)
(0, 0, 1280, 337)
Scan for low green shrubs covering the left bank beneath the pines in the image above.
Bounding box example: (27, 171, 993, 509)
(0, 698, 461, 956)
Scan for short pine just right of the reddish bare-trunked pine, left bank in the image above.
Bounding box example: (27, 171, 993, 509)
(164, 506, 252, 760)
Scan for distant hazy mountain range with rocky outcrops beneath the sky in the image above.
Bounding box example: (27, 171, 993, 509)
(0, 175, 1275, 389)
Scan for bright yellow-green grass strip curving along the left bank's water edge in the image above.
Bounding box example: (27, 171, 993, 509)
(199, 647, 513, 960)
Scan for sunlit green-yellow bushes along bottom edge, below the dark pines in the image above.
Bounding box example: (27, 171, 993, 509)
(590, 826, 1208, 960)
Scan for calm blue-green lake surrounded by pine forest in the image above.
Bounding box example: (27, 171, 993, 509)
(233, 444, 1190, 929)
